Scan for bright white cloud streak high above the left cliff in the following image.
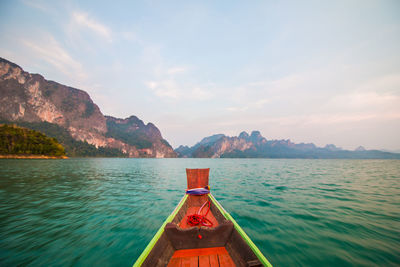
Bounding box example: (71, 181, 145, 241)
(71, 11, 112, 42)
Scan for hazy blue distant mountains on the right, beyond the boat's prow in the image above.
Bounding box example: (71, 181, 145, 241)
(175, 131, 400, 159)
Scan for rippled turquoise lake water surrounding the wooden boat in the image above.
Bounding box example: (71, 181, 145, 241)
(0, 159, 400, 266)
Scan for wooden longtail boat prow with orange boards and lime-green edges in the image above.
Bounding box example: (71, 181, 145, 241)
(133, 169, 272, 267)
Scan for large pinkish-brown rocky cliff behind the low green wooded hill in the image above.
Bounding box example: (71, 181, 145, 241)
(0, 58, 176, 157)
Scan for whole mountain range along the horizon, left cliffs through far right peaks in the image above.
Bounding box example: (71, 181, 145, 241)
(0, 58, 400, 159)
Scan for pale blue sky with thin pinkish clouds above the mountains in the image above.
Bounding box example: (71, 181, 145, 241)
(0, 0, 400, 151)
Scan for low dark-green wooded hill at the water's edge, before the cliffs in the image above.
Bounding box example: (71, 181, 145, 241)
(0, 124, 67, 159)
